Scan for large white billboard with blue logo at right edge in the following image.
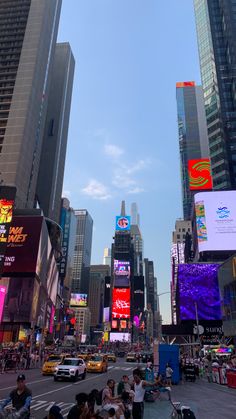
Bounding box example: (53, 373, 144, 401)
(194, 191, 236, 252)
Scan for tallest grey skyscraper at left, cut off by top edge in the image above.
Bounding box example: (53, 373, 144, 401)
(0, 0, 61, 208)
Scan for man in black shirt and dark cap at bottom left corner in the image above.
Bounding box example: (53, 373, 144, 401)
(0, 374, 32, 419)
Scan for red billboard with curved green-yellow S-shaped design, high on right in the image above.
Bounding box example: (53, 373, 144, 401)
(188, 159, 213, 191)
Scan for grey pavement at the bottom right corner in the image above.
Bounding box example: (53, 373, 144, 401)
(144, 380, 236, 419)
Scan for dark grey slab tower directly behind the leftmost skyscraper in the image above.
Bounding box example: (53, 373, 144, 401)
(36, 43, 75, 222)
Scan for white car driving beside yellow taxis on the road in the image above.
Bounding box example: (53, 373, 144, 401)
(54, 358, 87, 381)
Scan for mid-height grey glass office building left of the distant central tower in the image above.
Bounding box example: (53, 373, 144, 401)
(71, 209, 93, 294)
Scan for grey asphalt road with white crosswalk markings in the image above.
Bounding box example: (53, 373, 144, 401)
(0, 359, 139, 419)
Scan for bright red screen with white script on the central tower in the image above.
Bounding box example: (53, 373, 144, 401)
(112, 288, 130, 319)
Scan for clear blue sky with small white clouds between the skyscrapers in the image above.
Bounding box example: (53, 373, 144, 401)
(58, 0, 200, 323)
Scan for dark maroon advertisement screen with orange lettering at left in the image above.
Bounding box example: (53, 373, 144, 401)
(4, 216, 43, 276)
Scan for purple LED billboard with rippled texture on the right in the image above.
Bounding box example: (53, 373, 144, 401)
(178, 263, 222, 320)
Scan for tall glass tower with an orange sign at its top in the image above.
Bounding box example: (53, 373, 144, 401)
(176, 82, 209, 220)
